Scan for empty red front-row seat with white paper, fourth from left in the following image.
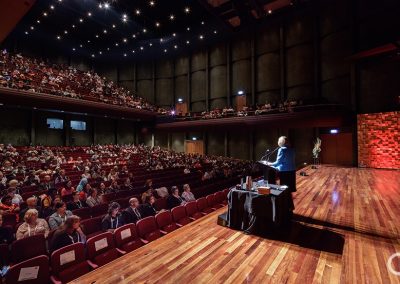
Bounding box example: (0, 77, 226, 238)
(114, 223, 144, 252)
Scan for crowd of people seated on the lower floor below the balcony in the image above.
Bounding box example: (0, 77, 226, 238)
(0, 145, 256, 249)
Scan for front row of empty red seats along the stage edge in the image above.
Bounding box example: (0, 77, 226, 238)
(0, 189, 229, 284)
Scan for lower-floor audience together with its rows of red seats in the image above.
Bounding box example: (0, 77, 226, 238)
(0, 144, 260, 280)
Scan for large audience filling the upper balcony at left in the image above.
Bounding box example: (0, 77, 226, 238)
(0, 50, 166, 114)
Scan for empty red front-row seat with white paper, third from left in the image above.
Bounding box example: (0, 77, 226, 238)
(86, 232, 124, 268)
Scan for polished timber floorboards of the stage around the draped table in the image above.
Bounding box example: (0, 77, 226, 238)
(72, 166, 400, 284)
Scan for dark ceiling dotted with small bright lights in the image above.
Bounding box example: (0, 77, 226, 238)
(7, 0, 299, 60)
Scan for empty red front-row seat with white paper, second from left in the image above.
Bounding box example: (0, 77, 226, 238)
(50, 243, 90, 283)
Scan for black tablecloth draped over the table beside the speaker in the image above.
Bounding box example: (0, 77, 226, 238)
(227, 184, 294, 235)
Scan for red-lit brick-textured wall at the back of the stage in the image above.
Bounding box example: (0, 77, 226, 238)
(357, 111, 400, 169)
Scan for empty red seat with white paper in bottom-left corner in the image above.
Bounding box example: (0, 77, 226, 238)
(5, 255, 50, 284)
